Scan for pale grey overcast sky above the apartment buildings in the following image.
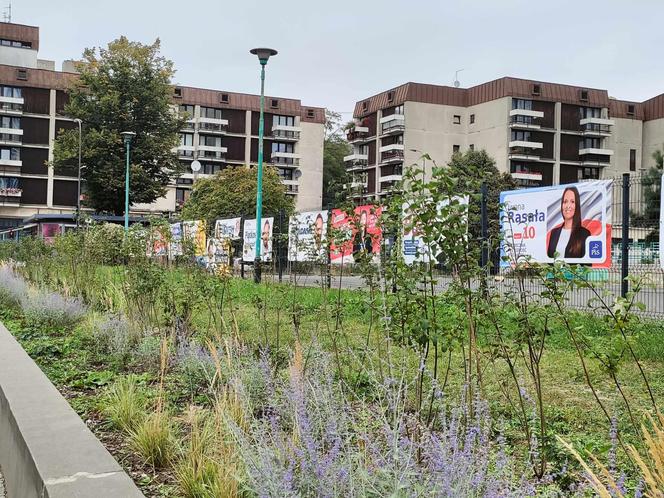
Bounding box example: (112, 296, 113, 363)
(13, 0, 664, 117)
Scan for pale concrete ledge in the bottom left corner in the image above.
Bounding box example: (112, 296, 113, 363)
(0, 323, 143, 498)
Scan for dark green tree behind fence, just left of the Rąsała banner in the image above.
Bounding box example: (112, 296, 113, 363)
(448, 150, 518, 265)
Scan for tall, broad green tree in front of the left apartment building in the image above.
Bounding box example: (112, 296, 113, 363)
(54, 37, 183, 215)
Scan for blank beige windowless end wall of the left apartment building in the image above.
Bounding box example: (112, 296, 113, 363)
(295, 122, 325, 211)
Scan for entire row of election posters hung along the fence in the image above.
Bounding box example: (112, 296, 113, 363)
(151, 180, 616, 268)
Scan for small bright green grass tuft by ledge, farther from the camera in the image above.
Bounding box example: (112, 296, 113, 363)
(101, 375, 146, 433)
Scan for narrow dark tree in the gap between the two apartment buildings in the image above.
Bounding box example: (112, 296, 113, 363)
(323, 110, 351, 208)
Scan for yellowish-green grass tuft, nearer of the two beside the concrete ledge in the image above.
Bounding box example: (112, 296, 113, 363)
(129, 410, 174, 468)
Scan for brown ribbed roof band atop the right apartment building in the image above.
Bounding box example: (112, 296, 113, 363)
(354, 77, 628, 117)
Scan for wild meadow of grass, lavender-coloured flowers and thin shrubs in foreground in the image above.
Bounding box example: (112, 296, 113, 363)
(0, 165, 664, 497)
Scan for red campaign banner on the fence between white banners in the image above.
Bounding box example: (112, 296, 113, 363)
(330, 205, 383, 264)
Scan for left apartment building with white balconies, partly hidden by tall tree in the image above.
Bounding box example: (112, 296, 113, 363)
(0, 23, 325, 230)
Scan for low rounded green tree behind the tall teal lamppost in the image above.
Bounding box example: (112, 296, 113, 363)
(182, 166, 293, 230)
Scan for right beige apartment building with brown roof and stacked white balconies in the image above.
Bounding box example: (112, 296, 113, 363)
(345, 77, 664, 199)
